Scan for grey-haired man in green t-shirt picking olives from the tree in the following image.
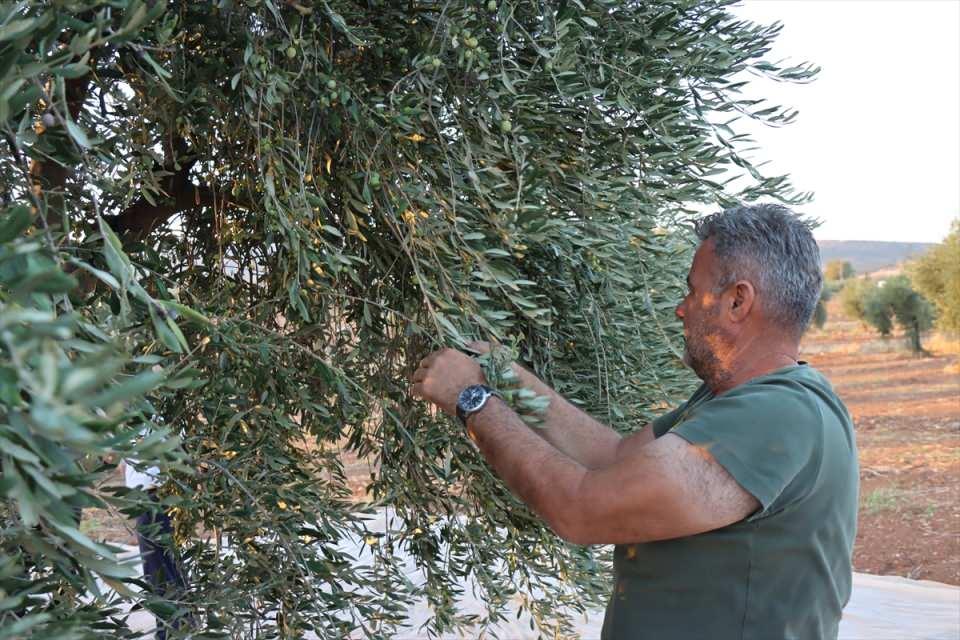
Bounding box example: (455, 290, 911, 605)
(413, 205, 859, 640)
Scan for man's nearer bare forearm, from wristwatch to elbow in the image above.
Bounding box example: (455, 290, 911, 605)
(468, 398, 588, 542)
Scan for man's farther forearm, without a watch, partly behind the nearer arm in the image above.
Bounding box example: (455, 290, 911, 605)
(513, 364, 621, 469)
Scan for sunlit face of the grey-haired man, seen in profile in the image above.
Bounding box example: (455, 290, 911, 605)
(676, 239, 732, 382)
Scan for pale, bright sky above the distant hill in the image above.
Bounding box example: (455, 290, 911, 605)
(733, 0, 960, 242)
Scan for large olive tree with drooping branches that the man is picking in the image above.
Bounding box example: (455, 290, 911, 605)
(0, 0, 816, 638)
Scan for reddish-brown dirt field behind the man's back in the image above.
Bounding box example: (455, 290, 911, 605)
(803, 308, 960, 585)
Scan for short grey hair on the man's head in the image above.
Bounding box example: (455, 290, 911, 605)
(695, 204, 823, 336)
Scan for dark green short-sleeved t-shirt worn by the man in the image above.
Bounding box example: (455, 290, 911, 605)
(603, 364, 859, 640)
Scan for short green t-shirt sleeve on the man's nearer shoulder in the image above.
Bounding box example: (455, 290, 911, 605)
(670, 380, 823, 518)
